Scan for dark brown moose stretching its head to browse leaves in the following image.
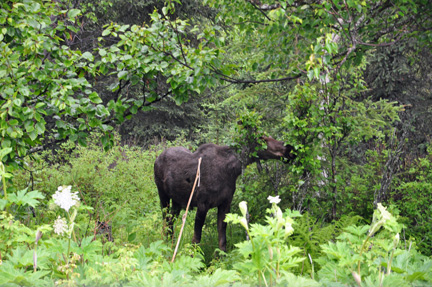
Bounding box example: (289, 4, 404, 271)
(154, 137, 294, 251)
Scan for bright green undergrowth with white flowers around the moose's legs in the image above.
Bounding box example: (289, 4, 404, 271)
(0, 138, 432, 286)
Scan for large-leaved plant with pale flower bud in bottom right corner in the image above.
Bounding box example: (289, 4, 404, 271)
(317, 204, 432, 286)
